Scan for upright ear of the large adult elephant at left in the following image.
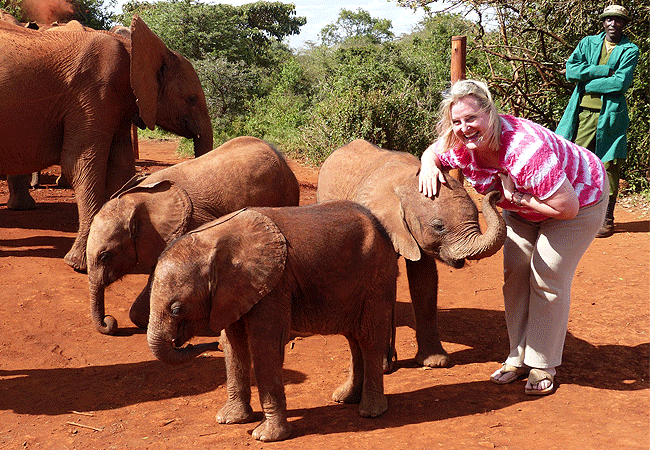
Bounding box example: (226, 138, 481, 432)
(131, 15, 169, 130)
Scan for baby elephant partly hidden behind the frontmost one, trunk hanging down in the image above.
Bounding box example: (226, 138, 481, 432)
(87, 136, 300, 334)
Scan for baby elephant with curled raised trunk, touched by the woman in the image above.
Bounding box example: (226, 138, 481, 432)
(317, 140, 506, 367)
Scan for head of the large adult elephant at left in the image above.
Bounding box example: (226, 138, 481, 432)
(131, 15, 212, 156)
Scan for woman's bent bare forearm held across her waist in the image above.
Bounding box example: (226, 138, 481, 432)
(499, 173, 580, 219)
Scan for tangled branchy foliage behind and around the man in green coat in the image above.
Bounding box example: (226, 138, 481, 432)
(398, 0, 650, 191)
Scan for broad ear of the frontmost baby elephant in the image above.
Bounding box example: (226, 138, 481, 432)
(208, 209, 287, 333)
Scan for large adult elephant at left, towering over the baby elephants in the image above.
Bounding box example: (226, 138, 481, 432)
(0, 16, 212, 271)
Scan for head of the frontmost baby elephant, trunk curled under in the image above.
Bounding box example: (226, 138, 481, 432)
(147, 209, 287, 364)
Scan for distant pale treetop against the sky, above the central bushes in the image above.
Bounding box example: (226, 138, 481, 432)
(319, 8, 394, 47)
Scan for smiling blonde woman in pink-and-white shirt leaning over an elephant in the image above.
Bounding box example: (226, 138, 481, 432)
(420, 80, 608, 395)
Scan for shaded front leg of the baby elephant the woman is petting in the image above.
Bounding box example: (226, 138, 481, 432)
(406, 254, 450, 367)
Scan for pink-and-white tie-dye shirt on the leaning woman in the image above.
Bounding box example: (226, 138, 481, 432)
(436, 114, 607, 222)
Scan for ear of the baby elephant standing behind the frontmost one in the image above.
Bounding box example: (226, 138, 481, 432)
(121, 180, 192, 245)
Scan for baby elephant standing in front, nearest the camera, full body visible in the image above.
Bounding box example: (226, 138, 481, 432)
(147, 201, 397, 441)
